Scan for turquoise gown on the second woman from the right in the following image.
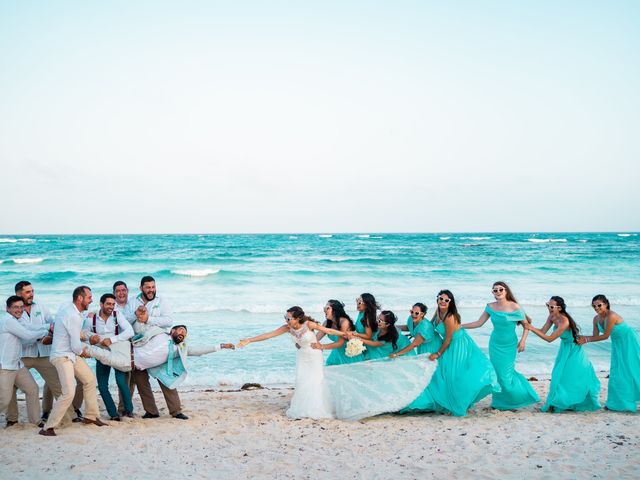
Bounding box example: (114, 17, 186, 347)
(542, 326, 601, 412)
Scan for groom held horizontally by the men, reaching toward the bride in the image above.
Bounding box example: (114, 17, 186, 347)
(84, 325, 235, 388)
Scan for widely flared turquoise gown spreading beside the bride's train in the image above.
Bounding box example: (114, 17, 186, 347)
(401, 323, 500, 417)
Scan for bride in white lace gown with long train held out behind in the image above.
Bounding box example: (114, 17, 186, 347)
(237, 306, 436, 420)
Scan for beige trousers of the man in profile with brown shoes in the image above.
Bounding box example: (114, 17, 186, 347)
(44, 357, 100, 429)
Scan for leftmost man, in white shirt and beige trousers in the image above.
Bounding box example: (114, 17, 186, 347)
(0, 295, 49, 424)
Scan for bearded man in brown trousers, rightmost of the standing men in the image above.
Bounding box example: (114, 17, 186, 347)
(131, 276, 189, 420)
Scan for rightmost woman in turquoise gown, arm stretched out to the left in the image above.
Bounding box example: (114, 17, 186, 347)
(578, 295, 640, 412)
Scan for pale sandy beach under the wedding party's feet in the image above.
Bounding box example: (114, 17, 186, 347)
(0, 378, 640, 479)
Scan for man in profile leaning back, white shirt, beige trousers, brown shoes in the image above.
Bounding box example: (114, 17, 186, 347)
(39, 285, 107, 436)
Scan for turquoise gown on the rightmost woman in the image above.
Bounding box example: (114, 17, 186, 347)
(598, 322, 640, 412)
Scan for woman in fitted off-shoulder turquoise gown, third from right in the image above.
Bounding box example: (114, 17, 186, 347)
(462, 282, 540, 410)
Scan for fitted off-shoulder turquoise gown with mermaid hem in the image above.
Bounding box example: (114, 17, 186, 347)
(485, 305, 540, 410)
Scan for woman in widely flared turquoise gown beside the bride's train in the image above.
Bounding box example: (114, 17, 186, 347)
(402, 290, 500, 417)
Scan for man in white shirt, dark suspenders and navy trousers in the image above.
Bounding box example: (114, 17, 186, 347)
(84, 293, 133, 422)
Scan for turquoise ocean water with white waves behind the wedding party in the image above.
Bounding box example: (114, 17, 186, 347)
(0, 233, 640, 387)
